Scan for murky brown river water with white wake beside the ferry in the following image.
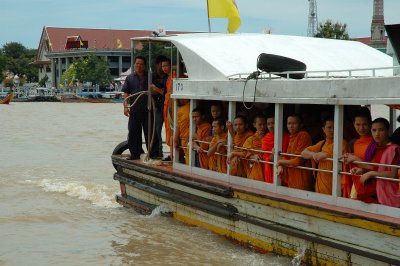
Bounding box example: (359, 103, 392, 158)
(0, 102, 291, 265)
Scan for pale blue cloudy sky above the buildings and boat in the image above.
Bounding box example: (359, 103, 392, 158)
(0, 0, 400, 48)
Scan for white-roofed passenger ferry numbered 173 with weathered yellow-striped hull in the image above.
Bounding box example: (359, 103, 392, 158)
(111, 33, 400, 265)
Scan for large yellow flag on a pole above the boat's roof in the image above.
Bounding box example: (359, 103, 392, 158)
(207, 0, 240, 33)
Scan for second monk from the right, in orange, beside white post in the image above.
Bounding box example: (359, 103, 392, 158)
(342, 107, 373, 199)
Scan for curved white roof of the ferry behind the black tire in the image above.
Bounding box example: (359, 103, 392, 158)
(132, 33, 393, 80)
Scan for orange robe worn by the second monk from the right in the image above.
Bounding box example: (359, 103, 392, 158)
(342, 136, 374, 198)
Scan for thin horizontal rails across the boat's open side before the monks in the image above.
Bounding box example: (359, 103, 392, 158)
(192, 140, 400, 182)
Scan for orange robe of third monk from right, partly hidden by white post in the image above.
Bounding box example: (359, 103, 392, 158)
(307, 140, 350, 195)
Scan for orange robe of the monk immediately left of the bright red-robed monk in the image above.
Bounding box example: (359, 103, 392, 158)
(243, 133, 264, 181)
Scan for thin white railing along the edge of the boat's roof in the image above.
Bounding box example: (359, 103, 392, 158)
(228, 66, 400, 80)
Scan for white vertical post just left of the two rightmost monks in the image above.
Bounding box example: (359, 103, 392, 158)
(332, 104, 344, 198)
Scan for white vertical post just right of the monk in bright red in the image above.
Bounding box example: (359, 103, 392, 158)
(273, 103, 284, 191)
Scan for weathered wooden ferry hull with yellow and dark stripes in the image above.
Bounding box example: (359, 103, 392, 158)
(112, 155, 400, 265)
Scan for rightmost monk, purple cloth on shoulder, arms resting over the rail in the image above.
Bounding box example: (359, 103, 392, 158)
(347, 117, 398, 203)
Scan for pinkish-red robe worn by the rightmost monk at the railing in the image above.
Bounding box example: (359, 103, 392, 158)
(376, 144, 400, 207)
